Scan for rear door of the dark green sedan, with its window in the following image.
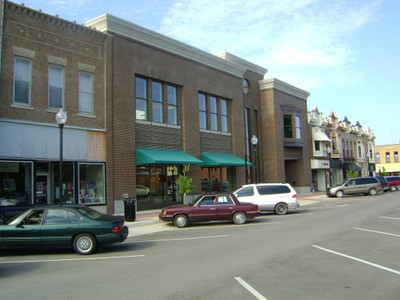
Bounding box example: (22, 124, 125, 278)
(41, 207, 80, 247)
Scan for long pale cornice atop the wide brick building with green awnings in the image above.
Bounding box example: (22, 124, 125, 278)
(85, 14, 246, 78)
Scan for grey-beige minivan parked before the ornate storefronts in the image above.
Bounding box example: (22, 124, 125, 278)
(326, 177, 383, 198)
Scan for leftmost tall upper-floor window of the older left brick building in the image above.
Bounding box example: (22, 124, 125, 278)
(13, 57, 32, 105)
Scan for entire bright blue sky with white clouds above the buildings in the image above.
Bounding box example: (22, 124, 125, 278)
(13, 0, 400, 145)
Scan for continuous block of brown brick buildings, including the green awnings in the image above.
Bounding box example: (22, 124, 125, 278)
(0, 1, 310, 213)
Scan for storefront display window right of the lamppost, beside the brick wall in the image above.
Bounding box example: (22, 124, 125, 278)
(78, 163, 105, 204)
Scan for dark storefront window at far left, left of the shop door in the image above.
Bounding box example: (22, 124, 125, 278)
(0, 161, 33, 205)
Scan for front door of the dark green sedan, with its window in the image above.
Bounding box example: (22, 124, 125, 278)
(2, 209, 44, 247)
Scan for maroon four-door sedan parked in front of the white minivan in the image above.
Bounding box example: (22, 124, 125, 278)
(159, 194, 261, 227)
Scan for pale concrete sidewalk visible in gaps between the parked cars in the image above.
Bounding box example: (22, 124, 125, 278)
(126, 192, 327, 237)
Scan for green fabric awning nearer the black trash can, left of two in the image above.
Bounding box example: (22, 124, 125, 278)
(136, 148, 203, 165)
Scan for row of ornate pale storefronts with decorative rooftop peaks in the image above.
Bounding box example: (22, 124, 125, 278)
(308, 108, 376, 191)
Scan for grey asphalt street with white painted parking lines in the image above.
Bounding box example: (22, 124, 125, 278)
(0, 192, 400, 300)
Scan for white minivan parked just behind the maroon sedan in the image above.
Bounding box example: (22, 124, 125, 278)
(233, 183, 300, 215)
